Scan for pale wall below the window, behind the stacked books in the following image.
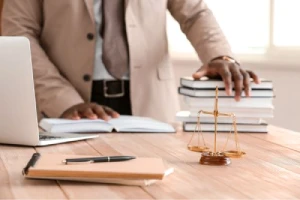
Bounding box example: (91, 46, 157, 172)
(173, 61, 300, 132)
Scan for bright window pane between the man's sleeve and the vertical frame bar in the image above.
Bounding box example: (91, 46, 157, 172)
(206, 0, 270, 53)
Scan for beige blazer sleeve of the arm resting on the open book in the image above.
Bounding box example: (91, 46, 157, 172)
(1, 0, 83, 117)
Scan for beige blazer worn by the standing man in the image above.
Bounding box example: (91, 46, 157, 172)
(2, 0, 232, 122)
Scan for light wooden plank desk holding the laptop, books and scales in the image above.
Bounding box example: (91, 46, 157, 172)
(0, 126, 300, 199)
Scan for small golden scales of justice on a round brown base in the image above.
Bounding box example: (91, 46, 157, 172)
(187, 87, 245, 165)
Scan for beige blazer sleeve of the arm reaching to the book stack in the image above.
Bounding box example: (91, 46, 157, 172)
(168, 0, 234, 64)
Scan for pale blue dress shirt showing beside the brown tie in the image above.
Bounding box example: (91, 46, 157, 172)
(93, 0, 129, 80)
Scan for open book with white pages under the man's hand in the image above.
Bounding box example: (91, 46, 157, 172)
(39, 116, 175, 133)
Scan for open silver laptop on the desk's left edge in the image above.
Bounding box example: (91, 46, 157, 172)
(0, 37, 98, 146)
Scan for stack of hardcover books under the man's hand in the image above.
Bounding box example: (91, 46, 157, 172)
(176, 77, 274, 133)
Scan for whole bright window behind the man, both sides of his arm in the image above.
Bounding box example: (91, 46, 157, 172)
(168, 0, 300, 63)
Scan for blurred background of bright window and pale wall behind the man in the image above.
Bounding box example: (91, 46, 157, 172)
(167, 0, 300, 131)
